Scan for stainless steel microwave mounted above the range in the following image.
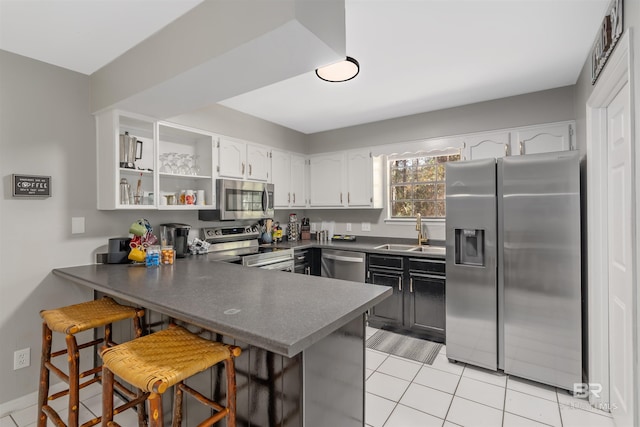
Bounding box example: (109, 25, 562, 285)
(198, 179, 274, 221)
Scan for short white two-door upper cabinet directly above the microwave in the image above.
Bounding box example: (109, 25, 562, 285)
(218, 137, 271, 181)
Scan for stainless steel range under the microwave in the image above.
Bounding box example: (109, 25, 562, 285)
(202, 225, 295, 272)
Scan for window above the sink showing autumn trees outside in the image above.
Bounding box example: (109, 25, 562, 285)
(389, 153, 460, 218)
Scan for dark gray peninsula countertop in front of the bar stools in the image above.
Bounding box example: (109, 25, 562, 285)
(51, 255, 392, 357)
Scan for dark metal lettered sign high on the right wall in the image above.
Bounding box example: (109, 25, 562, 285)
(591, 0, 623, 85)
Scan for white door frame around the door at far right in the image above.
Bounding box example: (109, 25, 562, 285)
(586, 29, 640, 420)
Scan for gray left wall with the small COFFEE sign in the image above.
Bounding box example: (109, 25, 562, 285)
(0, 50, 301, 414)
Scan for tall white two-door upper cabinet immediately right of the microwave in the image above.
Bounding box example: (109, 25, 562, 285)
(271, 149, 307, 209)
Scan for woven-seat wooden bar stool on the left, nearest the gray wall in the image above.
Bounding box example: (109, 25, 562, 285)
(38, 297, 146, 427)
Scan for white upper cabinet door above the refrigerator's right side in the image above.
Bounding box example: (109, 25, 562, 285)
(511, 122, 573, 155)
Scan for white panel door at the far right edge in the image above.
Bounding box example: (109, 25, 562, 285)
(607, 83, 634, 426)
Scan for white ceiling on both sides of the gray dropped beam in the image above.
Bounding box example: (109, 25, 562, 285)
(0, 0, 609, 133)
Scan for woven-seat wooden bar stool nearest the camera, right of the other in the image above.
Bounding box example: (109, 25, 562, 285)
(101, 324, 241, 427)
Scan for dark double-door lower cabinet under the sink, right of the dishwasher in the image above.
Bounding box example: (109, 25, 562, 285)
(367, 254, 445, 342)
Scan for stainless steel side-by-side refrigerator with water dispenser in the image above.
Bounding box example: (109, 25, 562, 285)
(446, 152, 582, 390)
